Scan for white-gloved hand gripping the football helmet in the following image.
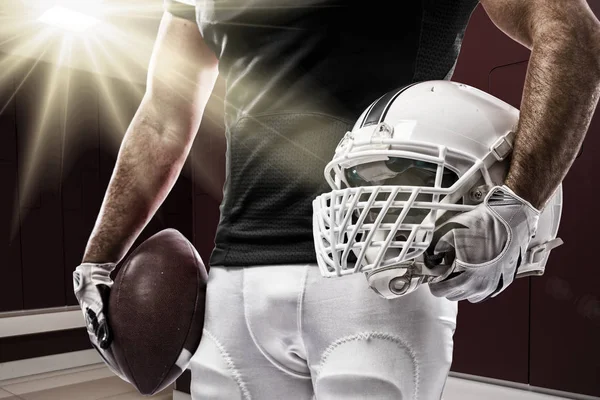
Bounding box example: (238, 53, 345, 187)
(429, 185, 540, 303)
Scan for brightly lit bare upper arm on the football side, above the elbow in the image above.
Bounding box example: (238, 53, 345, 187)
(145, 4, 218, 134)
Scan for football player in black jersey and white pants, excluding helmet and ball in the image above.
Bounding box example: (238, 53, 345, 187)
(75, 0, 600, 400)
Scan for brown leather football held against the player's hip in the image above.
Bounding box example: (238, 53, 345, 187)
(107, 229, 207, 395)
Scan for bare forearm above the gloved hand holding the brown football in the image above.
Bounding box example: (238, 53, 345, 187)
(82, 103, 191, 263)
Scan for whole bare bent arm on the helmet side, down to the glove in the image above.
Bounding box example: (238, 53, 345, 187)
(480, 0, 600, 209)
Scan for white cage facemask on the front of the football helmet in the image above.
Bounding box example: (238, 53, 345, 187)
(313, 123, 490, 276)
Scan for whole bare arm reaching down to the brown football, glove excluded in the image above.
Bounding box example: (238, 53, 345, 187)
(82, 3, 218, 263)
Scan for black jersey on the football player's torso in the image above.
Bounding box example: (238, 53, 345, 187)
(163, 0, 478, 266)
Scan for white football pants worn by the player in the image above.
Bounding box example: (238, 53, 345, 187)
(189, 265, 458, 400)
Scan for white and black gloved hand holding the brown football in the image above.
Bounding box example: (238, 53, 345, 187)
(73, 263, 129, 382)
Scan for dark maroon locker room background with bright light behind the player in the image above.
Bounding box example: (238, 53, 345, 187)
(0, 0, 600, 400)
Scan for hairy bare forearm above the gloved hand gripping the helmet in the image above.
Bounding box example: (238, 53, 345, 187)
(505, 21, 600, 209)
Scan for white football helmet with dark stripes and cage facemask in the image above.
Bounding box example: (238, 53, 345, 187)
(313, 81, 562, 297)
